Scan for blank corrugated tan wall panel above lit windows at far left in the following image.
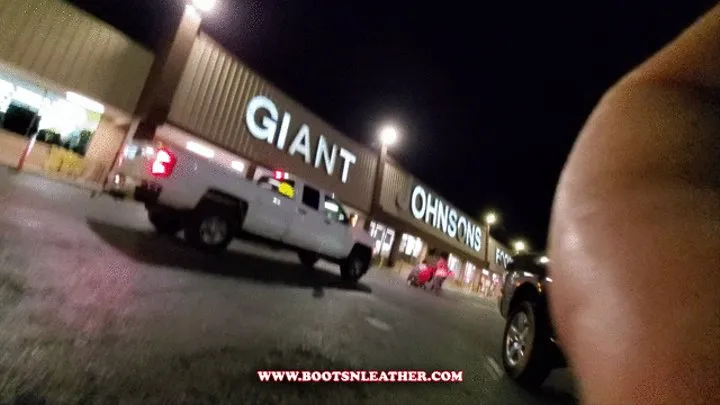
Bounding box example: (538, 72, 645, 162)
(0, 0, 154, 113)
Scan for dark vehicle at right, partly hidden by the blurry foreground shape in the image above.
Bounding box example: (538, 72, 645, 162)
(499, 254, 567, 387)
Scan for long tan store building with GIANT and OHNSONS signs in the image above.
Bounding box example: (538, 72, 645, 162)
(0, 0, 509, 291)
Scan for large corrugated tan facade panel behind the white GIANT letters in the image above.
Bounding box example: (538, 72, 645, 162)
(169, 34, 377, 212)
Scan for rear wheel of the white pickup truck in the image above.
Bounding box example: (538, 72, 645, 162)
(185, 207, 238, 252)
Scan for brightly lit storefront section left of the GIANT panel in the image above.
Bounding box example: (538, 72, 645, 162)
(0, 0, 154, 183)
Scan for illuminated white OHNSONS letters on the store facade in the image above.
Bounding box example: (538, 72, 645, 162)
(410, 185, 482, 252)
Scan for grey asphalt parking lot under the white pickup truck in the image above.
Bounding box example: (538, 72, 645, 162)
(0, 169, 577, 404)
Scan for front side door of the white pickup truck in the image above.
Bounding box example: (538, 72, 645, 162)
(320, 195, 353, 258)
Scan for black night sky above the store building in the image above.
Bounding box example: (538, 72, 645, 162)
(67, 0, 714, 248)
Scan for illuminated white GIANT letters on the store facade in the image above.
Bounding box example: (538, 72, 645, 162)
(245, 96, 357, 183)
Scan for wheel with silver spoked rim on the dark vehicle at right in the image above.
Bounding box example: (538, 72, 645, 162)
(502, 301, 553, 388)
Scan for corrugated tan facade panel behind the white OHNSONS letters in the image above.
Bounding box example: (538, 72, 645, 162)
(380, 163, 492, 264)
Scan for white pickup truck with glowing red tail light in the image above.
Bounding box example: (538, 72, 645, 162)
(106, 134, 374, 283)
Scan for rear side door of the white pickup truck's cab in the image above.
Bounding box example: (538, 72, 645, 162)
(283, 185, 326, 253)
